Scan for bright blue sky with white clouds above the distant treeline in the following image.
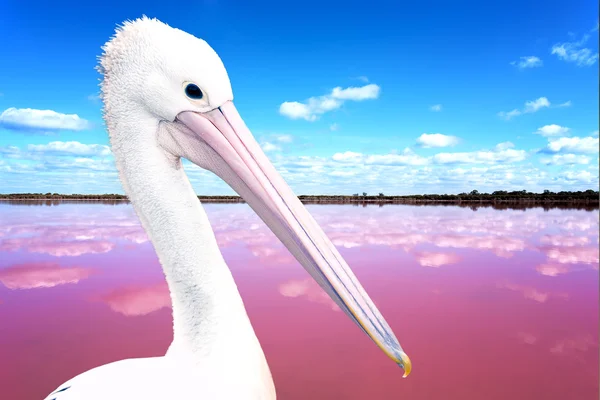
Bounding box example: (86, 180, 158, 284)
(0, 0, 599, 194)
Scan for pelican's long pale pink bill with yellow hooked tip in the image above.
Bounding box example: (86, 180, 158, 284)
(177, 101, 411, 377)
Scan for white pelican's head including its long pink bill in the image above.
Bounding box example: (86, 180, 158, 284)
(99, 17, 411, 377)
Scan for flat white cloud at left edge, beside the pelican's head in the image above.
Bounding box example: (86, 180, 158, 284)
(0, 107, 90, 131)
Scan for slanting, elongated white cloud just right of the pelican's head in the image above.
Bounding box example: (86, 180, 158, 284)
(279, 83, 380, 121)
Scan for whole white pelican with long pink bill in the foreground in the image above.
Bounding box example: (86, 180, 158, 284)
(46, 16, 411, 400)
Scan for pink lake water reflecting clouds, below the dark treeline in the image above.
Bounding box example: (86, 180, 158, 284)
(0, 203, 599, 400)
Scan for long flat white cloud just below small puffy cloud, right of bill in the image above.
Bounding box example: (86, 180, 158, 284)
(433, 142, 527, 164)
